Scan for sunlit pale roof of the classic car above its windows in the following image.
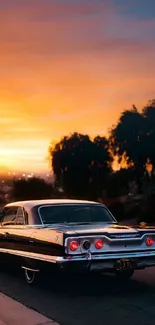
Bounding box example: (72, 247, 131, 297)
(5, 199, 104, 209)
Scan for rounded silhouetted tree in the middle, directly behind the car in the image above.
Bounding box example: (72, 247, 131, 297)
(49, 133, 112, 198)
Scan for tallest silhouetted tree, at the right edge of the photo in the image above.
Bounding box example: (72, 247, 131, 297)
(109, 100, 155, 191)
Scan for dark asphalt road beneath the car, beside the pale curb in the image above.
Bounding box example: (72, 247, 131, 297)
(0, 268, 155, 325)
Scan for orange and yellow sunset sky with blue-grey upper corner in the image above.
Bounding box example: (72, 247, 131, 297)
(0, 0, 155, 172)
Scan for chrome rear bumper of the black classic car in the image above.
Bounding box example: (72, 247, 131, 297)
(56, 251, 155, 272)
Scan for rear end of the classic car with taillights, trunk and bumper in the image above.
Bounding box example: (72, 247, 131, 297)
(53, 224, 155, 277)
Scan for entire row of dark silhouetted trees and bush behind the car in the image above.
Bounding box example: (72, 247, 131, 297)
(12, 100, 155, 223)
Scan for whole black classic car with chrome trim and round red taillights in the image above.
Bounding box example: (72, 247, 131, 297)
(0, 199, 155, 284)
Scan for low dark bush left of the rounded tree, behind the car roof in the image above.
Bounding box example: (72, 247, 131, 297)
(11, 177, 53, 201)
